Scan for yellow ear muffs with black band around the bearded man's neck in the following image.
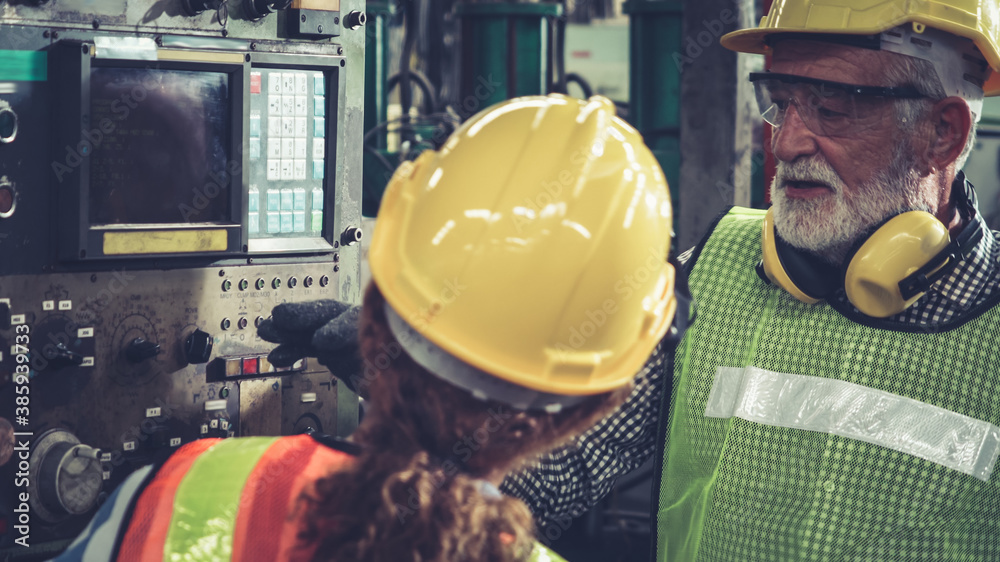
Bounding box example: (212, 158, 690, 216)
(757, 173, 985, 318)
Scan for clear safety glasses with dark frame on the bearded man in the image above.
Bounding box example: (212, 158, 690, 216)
(750, 72, 925, 137)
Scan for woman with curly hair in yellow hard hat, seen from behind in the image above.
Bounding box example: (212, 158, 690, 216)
(52, 96, 677, 562)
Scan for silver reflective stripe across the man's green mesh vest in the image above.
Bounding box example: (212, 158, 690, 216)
(705, 367, 1000, 481)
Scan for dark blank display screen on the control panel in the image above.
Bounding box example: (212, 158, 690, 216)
(83, 68, 231, 225)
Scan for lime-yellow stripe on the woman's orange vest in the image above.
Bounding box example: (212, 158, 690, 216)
(163, 437, 278, 561)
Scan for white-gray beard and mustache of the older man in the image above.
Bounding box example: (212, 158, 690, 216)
(771, 145, 938, 265)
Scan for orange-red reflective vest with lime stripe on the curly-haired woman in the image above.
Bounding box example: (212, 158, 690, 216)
(56, 435, 562, 562)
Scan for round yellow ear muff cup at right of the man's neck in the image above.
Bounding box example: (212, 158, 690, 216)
(844, 211, 953, 318)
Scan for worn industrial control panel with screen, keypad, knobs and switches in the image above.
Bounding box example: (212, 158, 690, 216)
(0, 0, 366, 560)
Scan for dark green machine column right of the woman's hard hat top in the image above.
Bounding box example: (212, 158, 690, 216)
(624, 0, 684, 231)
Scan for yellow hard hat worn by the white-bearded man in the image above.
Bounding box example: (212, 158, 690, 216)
(721, 0, 1000, 96)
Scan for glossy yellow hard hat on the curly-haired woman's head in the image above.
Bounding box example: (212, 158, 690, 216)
(369, 95, 677, 404)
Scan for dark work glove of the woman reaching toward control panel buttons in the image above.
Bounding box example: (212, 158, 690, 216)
(257, 299, 361, 392)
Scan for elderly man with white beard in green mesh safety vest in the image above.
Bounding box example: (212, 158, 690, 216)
(504, 0, 1000, 562)
